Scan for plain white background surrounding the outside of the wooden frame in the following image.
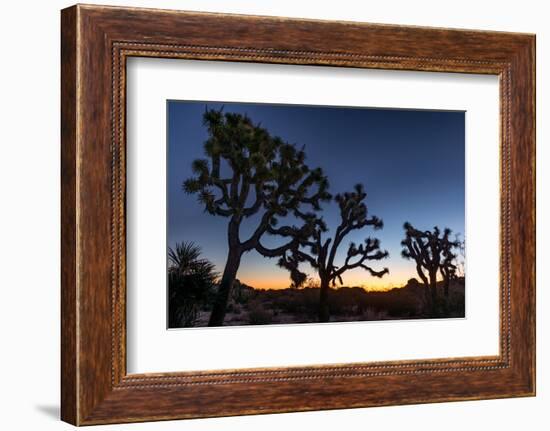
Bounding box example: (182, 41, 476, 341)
(0, 0, 550, 431)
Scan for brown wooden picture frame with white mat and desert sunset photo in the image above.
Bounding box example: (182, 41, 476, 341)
(61, 5, 535, 425)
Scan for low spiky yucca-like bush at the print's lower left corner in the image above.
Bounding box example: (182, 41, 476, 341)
(168, 242, 218, 328)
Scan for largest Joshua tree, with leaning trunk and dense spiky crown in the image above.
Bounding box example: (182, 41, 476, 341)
(183, 110, 330, 326)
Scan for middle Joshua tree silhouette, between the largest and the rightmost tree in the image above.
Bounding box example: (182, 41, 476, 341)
(279, 184, 389, 322)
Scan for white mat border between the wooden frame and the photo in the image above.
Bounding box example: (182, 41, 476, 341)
(126, 58, 500, 373)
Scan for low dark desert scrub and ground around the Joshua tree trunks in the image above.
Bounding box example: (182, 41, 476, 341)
(169, 277, 465, 326)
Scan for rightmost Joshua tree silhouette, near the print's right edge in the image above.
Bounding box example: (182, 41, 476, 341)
(401, 222, 458, 316)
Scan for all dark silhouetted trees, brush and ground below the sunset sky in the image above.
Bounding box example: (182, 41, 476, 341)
(168, 109, 465, 328)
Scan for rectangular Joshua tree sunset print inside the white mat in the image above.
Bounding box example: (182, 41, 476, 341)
(167, 100, 466, 328)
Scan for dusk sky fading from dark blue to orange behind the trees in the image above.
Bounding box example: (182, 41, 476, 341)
(167, 101, 465, 288)
